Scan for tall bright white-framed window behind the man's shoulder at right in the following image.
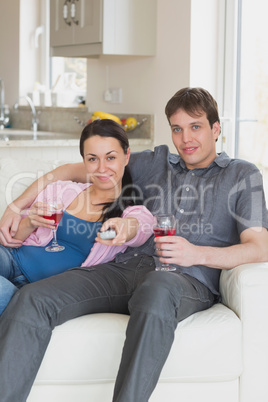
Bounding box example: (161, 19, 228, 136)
(222, 0, 268, 197)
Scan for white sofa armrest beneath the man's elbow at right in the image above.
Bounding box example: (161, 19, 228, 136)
(220, 262, 268, 402)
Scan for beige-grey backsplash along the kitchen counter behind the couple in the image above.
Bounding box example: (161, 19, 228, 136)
(11, 106, 154, 140)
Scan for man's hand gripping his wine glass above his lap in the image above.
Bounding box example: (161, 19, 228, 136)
(154, 236, 200, 267)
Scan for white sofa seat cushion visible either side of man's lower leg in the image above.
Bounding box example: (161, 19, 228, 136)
(35, 304, 242, 385)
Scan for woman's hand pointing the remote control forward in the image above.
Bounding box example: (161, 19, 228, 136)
(95, 217, 139, 246)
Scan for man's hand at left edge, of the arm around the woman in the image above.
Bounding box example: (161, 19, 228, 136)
(0, 206, 22, 248)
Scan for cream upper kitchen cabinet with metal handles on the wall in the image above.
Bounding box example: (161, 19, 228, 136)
(50, 0, 157, 57)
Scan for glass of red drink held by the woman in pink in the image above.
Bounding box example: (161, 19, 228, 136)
(43, 197, 65, 253)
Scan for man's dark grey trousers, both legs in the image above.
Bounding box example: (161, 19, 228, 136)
(0, 256, 214, 402)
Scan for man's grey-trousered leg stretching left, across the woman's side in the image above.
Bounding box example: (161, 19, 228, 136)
(0, 257, 154, 402)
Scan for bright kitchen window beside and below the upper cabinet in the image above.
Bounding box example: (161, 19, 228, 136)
(23, 0, 87, 107)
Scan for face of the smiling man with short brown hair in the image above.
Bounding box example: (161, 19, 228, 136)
(170, 109, 221, 169)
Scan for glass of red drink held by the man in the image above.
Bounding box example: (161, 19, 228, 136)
(153, 214, 176, 271)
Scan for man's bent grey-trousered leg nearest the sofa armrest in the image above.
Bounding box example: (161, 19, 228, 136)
(113, 271, 214, 402)
